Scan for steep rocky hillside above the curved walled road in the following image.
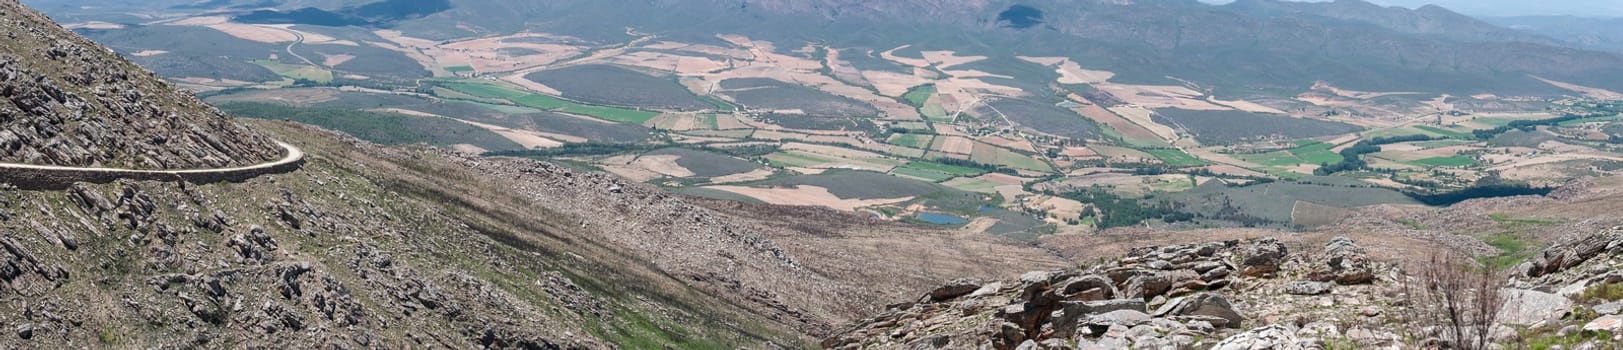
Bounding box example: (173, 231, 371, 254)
(0, 0, 282, 170)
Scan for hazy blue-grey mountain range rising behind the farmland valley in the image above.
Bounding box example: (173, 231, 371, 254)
(25, 0, 1623, 97)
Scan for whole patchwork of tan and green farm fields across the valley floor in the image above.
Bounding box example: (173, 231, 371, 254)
(167, 17, 1623, 238)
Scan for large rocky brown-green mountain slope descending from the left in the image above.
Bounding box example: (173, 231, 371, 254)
(0, 2, 1066, 348)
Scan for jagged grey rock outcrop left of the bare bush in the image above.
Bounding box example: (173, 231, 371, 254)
(823, 238, 1397, 348)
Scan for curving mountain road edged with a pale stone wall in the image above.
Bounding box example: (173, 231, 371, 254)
(0, 141, 305, 190)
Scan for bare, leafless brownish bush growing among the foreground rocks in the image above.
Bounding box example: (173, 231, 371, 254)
(1402, 256, 1506, 350)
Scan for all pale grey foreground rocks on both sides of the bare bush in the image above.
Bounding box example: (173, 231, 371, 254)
(823, 230, 1623, 350)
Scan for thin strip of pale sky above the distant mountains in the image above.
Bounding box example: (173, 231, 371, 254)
(1203, 0, 1623, 16)
